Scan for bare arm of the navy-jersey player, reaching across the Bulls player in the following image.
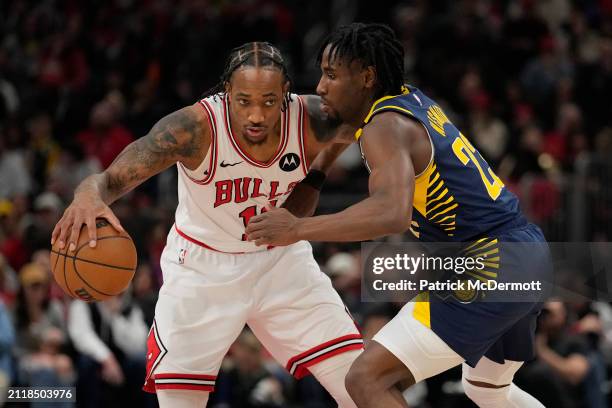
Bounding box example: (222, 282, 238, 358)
(247, 112, 418, 245)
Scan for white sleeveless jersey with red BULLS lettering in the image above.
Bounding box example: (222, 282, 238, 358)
(176, 94, 308, 253)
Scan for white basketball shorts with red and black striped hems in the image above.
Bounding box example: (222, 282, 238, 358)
(143, 228, 363, 392)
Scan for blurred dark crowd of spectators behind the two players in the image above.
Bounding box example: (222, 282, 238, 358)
(0, 0, 612, 408)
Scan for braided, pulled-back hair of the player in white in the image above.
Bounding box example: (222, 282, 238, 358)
(202, 42, 291, 111)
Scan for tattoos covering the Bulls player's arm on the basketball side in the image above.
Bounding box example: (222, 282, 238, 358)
(106, 108, 205, 193)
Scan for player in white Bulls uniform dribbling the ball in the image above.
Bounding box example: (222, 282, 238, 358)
(52, 43, 363, 408)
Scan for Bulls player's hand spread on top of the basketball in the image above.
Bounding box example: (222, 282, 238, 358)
(51, 193, 124, 252)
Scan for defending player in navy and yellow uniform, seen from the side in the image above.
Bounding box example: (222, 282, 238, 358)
(247, 23, 549, 408)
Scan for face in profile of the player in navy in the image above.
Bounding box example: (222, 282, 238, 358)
(317, 46, 368, 123)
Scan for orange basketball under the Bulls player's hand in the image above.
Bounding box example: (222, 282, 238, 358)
(51, 218, 138, 302)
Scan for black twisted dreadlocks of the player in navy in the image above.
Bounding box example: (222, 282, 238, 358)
(317, 23, 404, 98)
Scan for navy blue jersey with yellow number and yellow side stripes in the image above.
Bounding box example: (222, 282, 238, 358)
(356, 87, 525, 242)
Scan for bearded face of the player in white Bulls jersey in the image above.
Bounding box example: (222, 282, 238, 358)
(227, 67, 289, 144)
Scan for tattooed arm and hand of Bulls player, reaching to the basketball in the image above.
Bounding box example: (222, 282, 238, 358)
(51, 105, 210, 251)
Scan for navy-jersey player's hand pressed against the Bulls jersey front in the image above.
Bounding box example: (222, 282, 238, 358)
(246, 207, 299, 246)
